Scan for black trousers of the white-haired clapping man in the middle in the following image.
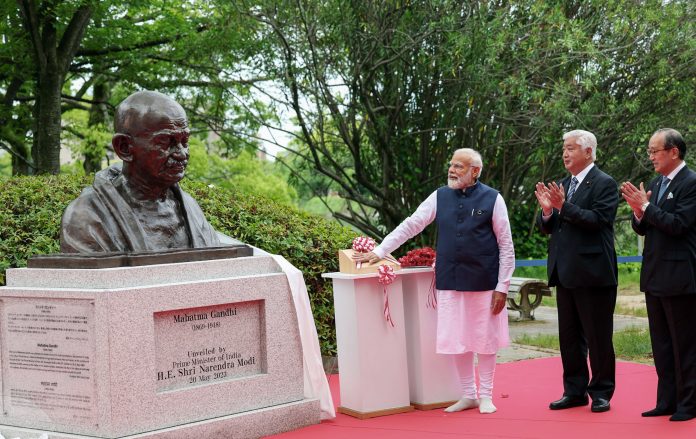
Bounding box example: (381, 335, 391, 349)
(556, 285, 616, 400)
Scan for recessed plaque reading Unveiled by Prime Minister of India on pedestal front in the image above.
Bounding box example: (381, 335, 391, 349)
(153, 300, 266, 392)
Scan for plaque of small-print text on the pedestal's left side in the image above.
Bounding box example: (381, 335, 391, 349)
(0, 297, 96, 427)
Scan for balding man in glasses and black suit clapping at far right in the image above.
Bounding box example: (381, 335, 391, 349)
(621, 128, 696, 421)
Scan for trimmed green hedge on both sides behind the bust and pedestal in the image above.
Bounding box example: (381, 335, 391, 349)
(0, 175, 356, 355)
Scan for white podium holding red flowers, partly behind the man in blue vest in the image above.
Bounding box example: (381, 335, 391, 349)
(400, 268, 461, 410)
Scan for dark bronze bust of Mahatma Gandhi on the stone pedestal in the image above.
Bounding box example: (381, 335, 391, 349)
(60, 91, 221, 253)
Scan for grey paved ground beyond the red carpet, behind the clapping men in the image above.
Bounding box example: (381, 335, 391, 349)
(498, 306, 648, 363)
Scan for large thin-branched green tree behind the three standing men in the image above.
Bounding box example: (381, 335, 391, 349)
(250, 0, 696, 251)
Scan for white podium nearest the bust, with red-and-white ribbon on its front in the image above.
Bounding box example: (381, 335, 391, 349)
(322, 272, 413, 419)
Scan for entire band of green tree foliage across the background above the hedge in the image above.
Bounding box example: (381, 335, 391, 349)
(0, 0, 696, 257)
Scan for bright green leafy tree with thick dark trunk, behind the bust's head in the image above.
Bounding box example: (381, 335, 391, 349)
(0, 0, 270, 173)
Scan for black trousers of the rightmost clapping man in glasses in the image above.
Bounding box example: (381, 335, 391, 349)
(645, 293, 696, 415)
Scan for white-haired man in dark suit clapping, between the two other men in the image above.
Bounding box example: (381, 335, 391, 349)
(535, 130, 619, 412)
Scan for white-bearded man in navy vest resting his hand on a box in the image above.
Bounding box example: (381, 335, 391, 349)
(354, 148, 515, 413)
